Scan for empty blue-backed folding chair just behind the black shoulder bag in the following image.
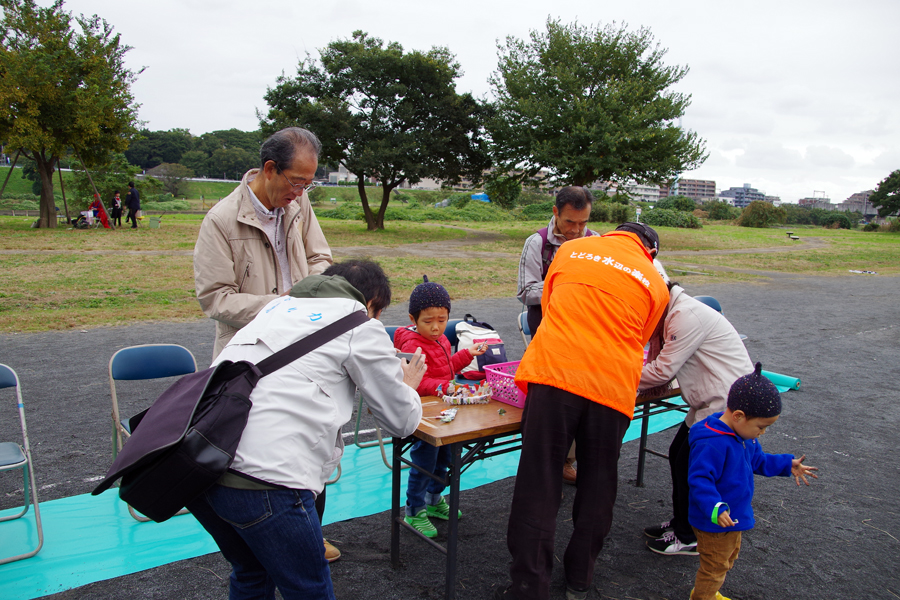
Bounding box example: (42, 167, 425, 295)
(109, 344, 197, 522)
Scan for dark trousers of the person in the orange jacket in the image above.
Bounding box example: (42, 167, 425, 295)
(506, 383, 630, 600)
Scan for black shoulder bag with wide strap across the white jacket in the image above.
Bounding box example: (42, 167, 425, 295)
(91, 311, 369, 523)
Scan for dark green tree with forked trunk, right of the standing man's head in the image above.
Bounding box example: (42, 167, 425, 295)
(261, 31, 489, 231)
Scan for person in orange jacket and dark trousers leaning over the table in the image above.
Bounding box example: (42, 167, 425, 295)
(495, 223, 669, 600)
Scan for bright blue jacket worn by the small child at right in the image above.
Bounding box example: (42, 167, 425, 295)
(688, 412, 794, 533)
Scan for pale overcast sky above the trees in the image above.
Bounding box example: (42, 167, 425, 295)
(54, 0, 900, 202)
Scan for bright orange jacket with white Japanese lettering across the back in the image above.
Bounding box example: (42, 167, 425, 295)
(516, 231, 669, 419)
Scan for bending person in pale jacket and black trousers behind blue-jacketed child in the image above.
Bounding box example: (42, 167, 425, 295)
(638, 265, 753, 555)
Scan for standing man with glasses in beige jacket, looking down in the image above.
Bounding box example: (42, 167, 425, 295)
(194, 127, 332, 359)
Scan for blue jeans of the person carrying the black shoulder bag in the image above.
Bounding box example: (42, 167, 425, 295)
(187, 485, 334, 600)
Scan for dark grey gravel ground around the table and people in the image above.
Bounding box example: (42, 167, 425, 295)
(0, 275, 900, 600)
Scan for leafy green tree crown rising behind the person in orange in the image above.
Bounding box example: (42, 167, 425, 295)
(488, 19, 707, 185)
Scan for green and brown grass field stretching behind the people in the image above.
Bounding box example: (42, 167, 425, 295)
(0, 215, 900, 332)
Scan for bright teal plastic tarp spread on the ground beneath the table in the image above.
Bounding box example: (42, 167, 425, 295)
(0, 371, 800, 600)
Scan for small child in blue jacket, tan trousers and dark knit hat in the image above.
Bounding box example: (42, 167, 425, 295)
(688, 363, 818, 600)
